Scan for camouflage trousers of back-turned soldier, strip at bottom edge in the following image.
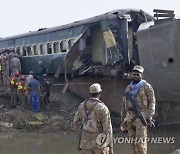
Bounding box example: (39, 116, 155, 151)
(80, 147, 109, 154)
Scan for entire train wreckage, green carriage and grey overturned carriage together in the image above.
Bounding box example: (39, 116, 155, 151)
(0, 9, 180, 123)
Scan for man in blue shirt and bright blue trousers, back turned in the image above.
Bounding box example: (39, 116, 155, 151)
(28, 74, 40, 112)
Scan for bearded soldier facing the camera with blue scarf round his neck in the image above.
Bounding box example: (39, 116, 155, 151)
(120, 65, 156, 154)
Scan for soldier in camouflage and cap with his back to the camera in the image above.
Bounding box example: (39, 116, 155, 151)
(73, 83, 113, 154)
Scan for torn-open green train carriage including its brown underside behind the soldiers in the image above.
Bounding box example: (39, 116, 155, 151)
(0, 9, 154, 112)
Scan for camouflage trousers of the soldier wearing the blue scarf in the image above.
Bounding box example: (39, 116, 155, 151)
(127, 118, 147, 154)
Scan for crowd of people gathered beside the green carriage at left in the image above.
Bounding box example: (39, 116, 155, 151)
(0, 51, 52, 112)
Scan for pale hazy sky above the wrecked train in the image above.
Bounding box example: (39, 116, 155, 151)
(0, 0, 180, 37)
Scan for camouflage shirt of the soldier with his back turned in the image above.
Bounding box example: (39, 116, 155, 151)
(73, 98, 113, 149)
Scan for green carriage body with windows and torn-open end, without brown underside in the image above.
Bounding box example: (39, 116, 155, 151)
(0, 10, 153, 75)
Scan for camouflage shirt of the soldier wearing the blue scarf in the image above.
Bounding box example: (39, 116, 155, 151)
(121, 82, 156, 121)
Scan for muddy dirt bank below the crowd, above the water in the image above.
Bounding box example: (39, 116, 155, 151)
(0, 87, 82, 134)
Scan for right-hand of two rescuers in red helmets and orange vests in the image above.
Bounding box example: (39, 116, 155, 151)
(18, 75, 26, 108)
